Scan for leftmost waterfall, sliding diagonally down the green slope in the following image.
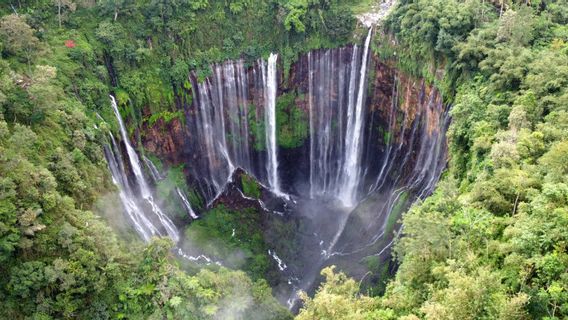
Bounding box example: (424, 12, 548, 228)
(110, 96, 179, 242)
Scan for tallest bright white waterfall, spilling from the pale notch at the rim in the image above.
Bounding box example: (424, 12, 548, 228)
(340, 28, 373, 207)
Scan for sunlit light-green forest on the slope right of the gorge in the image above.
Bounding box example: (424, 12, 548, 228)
(360, 1, 568, 319)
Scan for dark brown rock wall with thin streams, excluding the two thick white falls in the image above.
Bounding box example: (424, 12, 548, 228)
(140, 46, 447, 208)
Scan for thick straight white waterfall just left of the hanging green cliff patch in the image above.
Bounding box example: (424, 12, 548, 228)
(263, 53, 282, 195)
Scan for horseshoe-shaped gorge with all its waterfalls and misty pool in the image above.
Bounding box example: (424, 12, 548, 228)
(106, 29, 449, 306)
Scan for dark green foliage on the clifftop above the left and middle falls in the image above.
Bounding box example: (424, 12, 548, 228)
(77, 0, 355, 124)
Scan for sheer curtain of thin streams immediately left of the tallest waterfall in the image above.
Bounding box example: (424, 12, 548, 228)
(307, 45, 359, 198)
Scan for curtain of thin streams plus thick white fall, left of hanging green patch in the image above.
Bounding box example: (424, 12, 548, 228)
(188, 54, 283, 202)
